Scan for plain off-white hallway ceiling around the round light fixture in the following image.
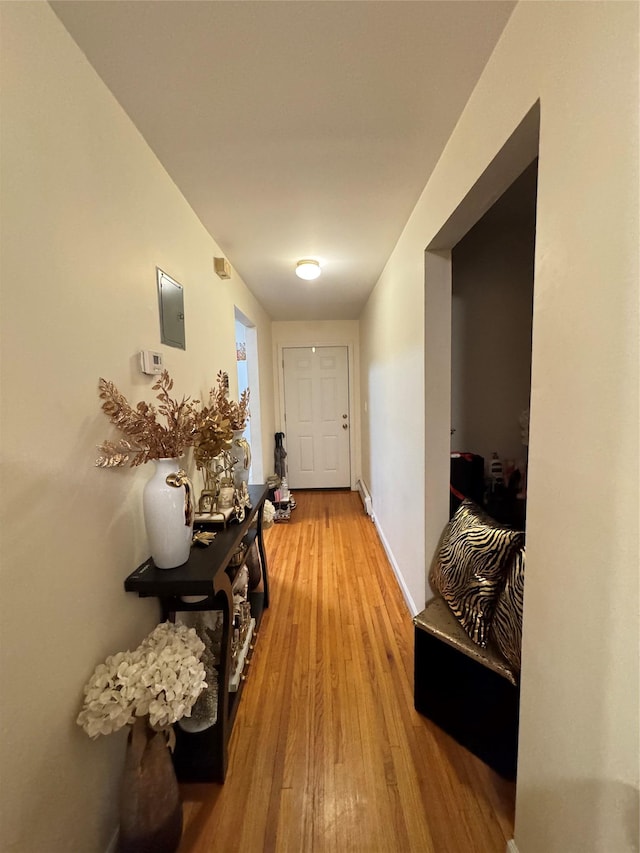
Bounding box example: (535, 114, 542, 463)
(51, 0, 515, 320)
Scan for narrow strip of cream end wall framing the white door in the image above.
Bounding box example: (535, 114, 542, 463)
(265, 320, 361, 488)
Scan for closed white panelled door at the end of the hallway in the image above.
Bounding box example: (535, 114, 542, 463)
(283, 347, 351, 489)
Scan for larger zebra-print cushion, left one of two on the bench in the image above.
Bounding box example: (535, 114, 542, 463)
(429, 499, 523, 648)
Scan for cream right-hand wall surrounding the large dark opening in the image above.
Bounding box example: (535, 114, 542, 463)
(361, 2, 640, 853)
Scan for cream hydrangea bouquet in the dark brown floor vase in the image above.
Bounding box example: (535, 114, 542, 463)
(77, 622, 207, 853)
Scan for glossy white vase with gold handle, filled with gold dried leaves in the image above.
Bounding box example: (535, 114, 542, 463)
(96, 370, 197, 569)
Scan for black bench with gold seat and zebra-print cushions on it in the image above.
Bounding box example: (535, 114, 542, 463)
(414, 500, 524, 778)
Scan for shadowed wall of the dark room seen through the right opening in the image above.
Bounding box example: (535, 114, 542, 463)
(451, 163, 536, 474)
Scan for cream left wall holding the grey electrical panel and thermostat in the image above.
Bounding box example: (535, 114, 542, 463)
(0, 3, 274, 853)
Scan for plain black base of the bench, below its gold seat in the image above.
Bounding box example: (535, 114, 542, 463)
(414, 604, 520, 779)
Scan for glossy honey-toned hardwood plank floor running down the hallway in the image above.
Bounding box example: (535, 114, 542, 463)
(180, 491, 515, 853)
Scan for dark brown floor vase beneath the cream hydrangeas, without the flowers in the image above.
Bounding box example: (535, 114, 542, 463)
(119, 717, 182, 853)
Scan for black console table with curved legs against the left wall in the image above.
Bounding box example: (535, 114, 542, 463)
(124, 485, 269, 782)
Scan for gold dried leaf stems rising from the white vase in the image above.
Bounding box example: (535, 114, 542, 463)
(96, 370, 199, 468)
